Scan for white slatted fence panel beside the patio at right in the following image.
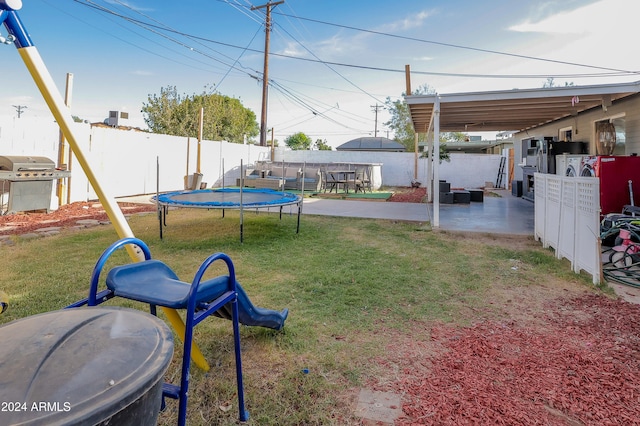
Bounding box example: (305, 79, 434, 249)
(534, 173, 602, 284)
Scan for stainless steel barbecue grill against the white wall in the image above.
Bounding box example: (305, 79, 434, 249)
(0, 155, 71, 214)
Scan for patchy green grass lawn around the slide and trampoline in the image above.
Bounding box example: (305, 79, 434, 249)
(0, 209, 590, 425)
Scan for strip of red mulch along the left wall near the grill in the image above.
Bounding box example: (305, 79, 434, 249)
(0, 202, 156, 235)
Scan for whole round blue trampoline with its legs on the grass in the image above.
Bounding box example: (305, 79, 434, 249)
(152, 188, 302, 242)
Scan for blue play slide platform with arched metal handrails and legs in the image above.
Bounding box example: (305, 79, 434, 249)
(68, 238, 249, 426)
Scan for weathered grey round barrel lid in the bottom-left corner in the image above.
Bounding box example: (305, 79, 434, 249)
(0, 307, 173, 425)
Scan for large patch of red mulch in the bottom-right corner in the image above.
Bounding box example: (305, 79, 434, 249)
(381, 295, 640, 425)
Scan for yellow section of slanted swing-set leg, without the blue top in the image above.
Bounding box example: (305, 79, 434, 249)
(18, 46, 209, 371)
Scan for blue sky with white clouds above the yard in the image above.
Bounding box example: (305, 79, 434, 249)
(0, 0, 640, 146)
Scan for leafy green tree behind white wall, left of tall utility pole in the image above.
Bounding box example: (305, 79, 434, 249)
(142, 86, 259, 143)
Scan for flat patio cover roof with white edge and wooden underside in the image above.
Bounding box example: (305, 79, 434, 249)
(405, 82, 640, 133)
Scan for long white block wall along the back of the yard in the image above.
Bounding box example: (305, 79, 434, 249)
(0, 117, 510, 205)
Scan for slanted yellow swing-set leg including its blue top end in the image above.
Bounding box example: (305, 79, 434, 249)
(5, 7, 209, 371)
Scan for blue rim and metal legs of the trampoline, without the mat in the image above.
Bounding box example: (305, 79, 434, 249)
(152, 187, 303, 242)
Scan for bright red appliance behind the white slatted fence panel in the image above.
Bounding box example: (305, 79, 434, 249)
(580, 155, 640, 216)
